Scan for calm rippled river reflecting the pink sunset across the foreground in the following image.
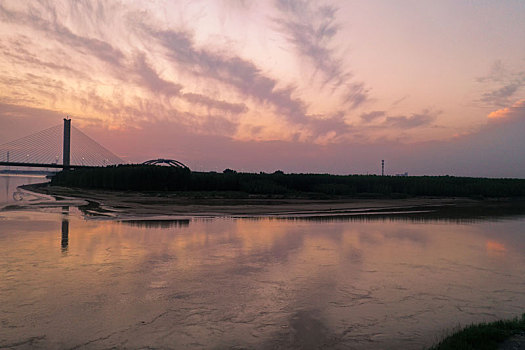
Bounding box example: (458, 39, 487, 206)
(0, 176, 525, 349)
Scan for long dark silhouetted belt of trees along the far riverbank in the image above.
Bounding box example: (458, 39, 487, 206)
(51, 165, 525, 198)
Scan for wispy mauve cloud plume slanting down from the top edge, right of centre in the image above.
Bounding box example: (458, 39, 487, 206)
(274, 0, 368, 108)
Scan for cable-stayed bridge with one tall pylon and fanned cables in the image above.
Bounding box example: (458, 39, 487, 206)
(0, 119, 124, 169)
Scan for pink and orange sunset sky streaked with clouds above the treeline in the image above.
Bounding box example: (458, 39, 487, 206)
(0, 0, 525, 178)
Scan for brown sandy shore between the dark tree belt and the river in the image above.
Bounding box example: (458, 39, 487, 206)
(12, 185, 488, 219)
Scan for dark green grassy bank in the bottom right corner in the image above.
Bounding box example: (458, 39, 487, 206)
(429, 314, 525, 350)
